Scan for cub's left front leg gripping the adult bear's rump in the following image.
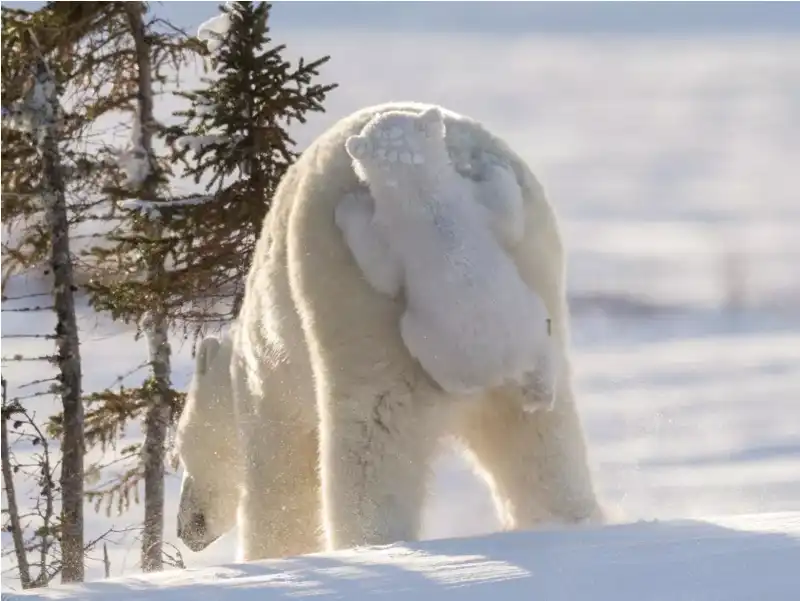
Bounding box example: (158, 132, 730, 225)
(335, 192, 403, 297)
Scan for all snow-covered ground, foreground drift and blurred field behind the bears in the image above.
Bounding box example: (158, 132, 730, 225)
(2, 22, 800, 601)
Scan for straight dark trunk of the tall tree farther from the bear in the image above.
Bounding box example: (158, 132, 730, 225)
(36, 59, 85, 582)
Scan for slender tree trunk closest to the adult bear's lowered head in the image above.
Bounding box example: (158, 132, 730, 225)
(125, 2, 172, 572)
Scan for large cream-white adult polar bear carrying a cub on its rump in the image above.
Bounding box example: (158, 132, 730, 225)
(177, 103, 603, 560)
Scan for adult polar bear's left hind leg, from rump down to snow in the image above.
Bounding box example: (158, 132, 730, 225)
(288, 154, 450, 549)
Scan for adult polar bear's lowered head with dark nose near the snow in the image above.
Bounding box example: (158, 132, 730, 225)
(175, 337, 241, 551)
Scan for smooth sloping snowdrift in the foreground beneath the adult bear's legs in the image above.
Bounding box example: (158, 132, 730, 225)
(3, 512, 800, 601)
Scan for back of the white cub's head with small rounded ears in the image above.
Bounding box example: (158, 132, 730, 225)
(345, 107, 449, 181)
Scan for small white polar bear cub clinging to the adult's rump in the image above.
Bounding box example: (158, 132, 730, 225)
(336, 108, 557, 410)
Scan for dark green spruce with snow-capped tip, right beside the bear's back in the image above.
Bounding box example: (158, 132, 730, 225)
(169, 2, 336, 334)
